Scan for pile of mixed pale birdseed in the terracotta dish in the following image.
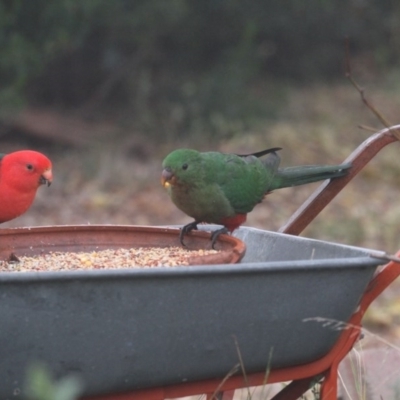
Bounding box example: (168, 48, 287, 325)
(0, 247, 218, 272)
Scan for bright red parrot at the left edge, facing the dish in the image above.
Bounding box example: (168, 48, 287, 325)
(0, 150, 53, 223)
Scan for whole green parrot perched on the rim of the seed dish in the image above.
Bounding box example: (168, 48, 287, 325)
(161, 147, 351, 247)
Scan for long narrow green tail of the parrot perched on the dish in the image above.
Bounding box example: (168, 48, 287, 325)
(269, 164, 351, 191)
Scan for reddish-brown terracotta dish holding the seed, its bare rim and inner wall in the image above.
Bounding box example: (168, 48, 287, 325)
(0, 225, 246, 265)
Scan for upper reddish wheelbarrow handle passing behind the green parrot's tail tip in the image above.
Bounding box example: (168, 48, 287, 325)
(278, 125, 400, 235)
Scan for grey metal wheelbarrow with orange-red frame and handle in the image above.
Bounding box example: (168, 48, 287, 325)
(0, 127, 400, 400)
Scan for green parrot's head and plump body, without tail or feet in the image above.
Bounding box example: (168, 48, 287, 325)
(162, 149, 278, 223)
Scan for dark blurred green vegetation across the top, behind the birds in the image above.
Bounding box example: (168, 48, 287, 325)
(0, 0, 400, 142)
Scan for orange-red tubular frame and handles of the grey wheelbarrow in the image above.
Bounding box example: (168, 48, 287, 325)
(85, 125, 400, 400)
